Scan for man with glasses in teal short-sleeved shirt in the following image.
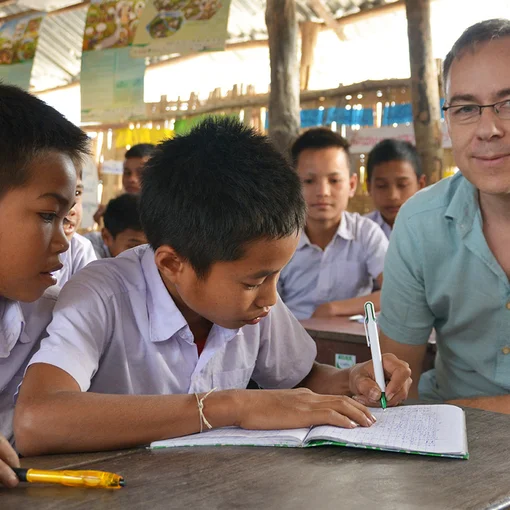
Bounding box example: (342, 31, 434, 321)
(379, 19, 510, 413)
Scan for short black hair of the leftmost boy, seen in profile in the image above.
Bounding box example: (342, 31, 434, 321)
(0, 82, 89, 196)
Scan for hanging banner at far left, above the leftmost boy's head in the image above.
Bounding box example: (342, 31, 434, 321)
(0, 12, 44, 90)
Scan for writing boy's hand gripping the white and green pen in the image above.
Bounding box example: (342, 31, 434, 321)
(349, 354, 413, 407)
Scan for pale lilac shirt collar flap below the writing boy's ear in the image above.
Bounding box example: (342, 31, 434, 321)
(138, 246, 188, 342)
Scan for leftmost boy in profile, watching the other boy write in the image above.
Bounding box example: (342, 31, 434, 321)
(0, 84, 88, 487)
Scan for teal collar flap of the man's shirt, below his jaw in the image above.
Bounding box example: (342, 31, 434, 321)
(444, 172, 480, 234)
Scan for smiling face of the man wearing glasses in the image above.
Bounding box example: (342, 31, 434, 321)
(446, 37, 510, 195)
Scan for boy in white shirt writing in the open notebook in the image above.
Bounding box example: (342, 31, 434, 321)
(15, 118, 411, 455)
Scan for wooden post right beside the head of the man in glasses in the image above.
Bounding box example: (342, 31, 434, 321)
(406, 0, 443, 184)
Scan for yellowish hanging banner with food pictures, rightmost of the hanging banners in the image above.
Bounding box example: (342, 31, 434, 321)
(131, 0, 231, 57)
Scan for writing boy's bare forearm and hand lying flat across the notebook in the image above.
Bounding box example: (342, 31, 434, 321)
(14, 363, 373, 456)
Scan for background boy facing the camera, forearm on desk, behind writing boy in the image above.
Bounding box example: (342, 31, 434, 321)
(278, 128, 388, 319)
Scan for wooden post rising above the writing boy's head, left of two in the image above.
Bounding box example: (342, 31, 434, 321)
(266, 0, 300, 155)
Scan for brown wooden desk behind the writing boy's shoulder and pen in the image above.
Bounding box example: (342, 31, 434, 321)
(299, 317, 436, 372)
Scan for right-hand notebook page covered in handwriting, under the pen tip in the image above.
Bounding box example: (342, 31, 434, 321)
(307, 405, 467, 454)
